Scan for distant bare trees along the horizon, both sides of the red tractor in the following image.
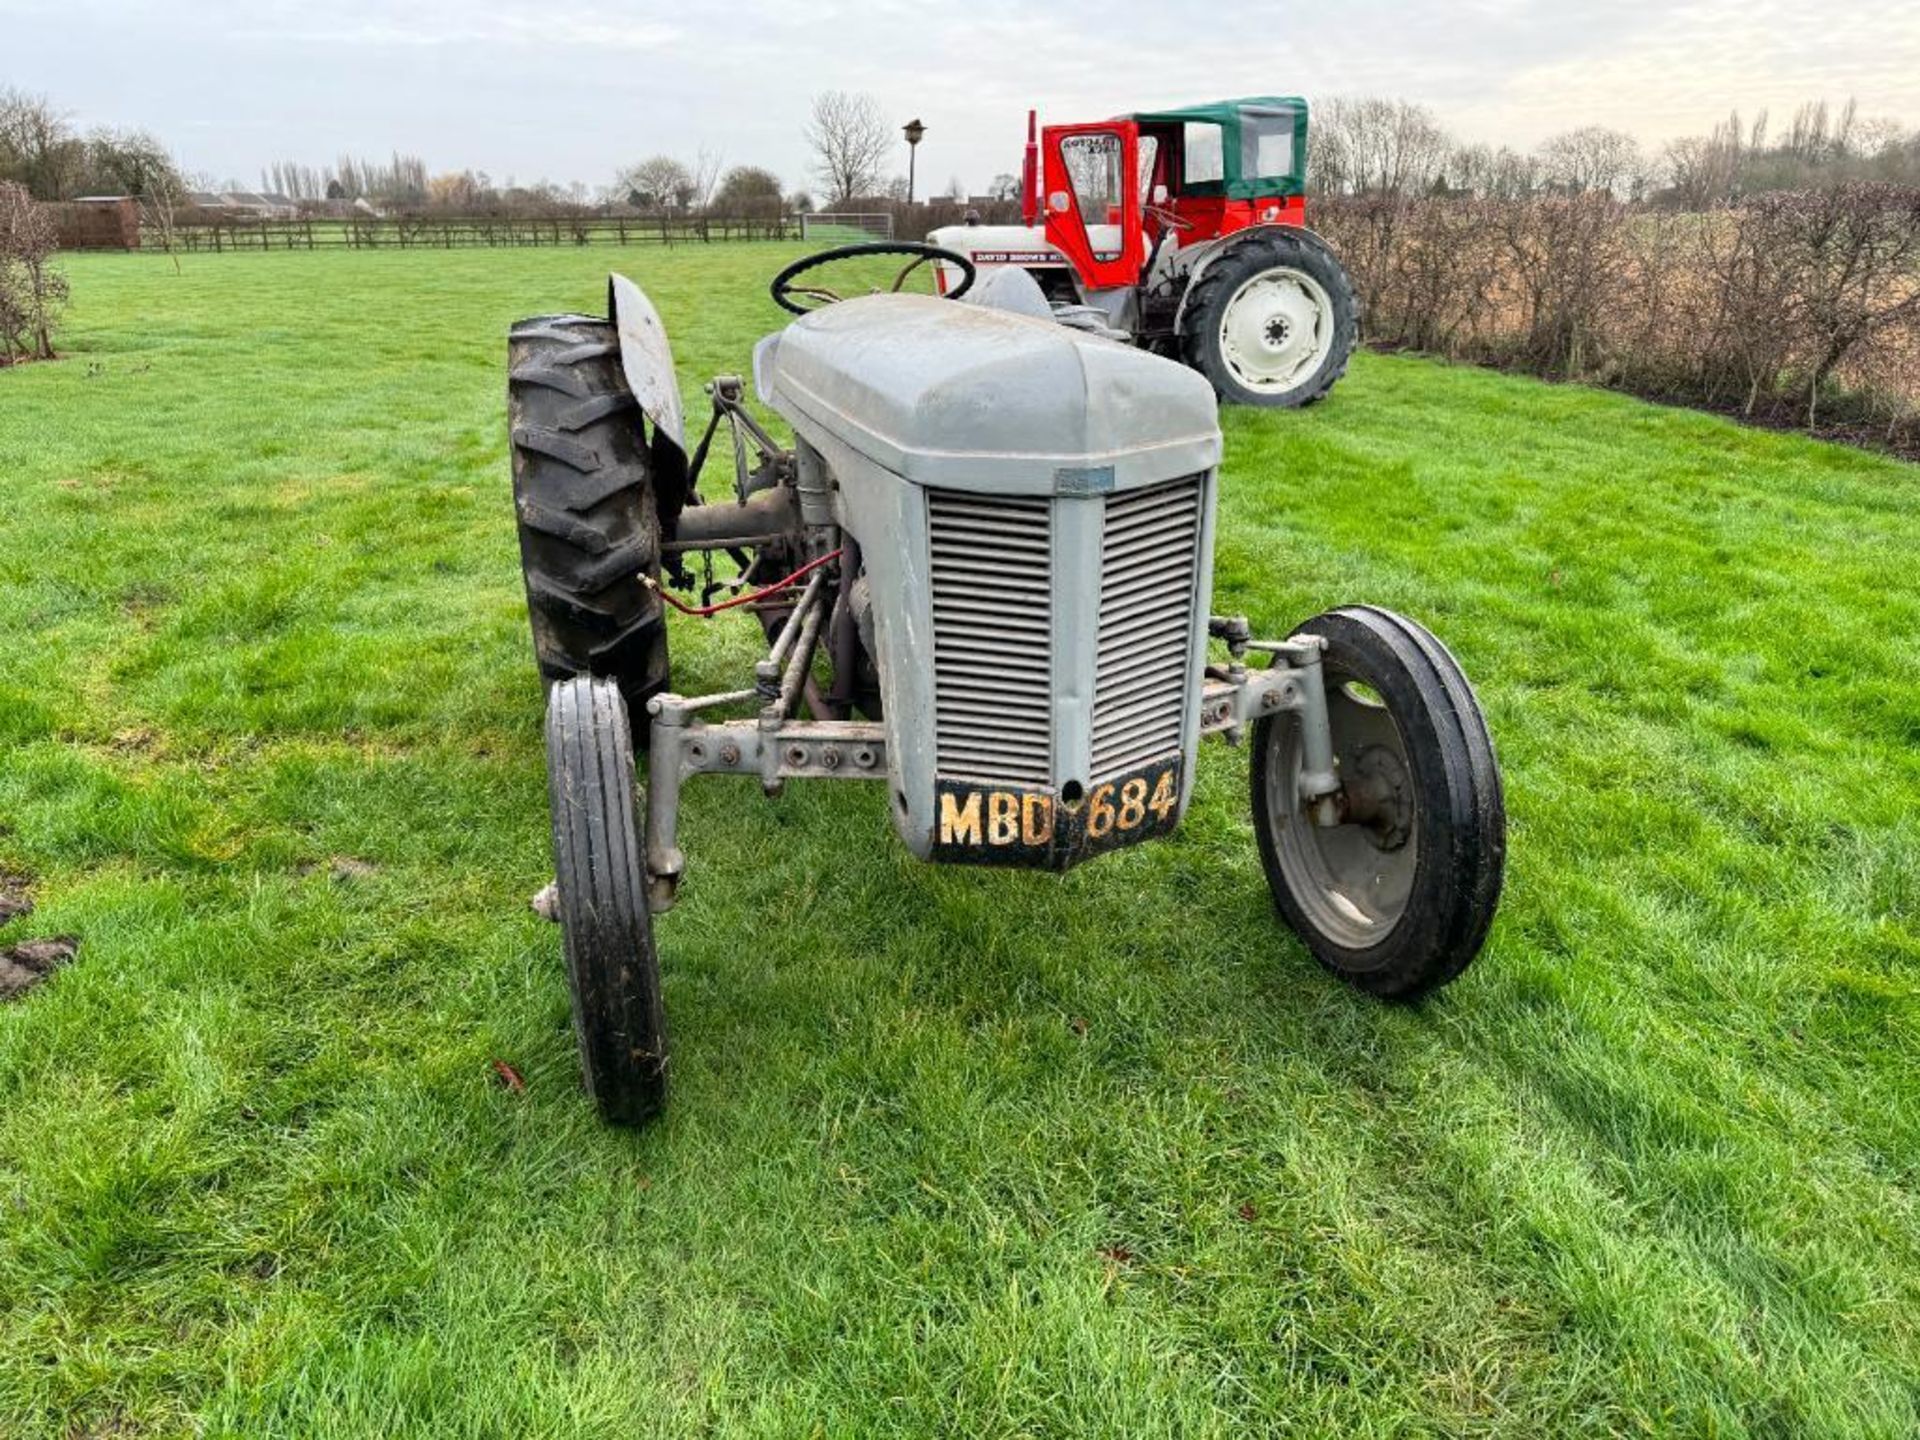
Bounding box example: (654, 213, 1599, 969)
(15, 80, 1920, 215)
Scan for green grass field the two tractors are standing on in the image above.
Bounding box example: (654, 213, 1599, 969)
(0, 246, 1920, 1440)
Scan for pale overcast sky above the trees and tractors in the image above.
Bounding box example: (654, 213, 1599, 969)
(0, 0, 1920, 192)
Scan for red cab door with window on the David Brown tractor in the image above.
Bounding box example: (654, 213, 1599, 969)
(1041, 121, 1144, 290)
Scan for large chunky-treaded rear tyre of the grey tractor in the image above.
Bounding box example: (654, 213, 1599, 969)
(507, 315, 668, 749)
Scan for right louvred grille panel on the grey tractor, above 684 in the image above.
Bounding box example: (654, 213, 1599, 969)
(1092, 476, 1202, 780)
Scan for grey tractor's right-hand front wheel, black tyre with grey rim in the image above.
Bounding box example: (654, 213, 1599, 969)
(1252, 605, 1507, 1000)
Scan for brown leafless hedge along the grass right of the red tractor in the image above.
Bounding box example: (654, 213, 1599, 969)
(1311, 180, 1920, 455)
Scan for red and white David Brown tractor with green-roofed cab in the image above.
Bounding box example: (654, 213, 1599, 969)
(927, 96, 1357, 407)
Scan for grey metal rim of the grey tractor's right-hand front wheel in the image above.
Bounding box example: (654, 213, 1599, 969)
(1265, 668, 1421, 950)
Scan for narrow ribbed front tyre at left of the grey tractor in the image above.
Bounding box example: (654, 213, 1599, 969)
(547, 676, 666, 1125)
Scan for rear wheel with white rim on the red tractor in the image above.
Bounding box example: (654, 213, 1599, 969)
(1181, 230, 1359, 409)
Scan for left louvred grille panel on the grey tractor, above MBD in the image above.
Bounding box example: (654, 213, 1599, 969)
(927, 490, 1052, 785)
